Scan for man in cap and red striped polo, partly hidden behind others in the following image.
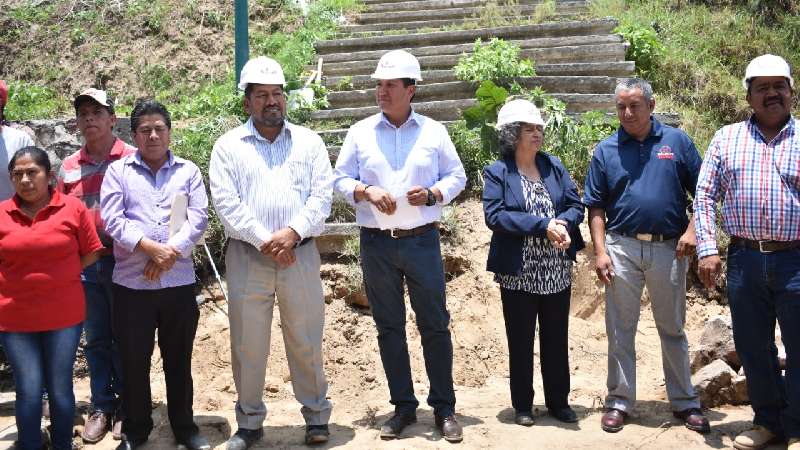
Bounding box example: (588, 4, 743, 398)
(57, 88, 136, 443)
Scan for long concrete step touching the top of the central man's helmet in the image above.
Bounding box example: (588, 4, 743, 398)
(316, 34, 624, 64)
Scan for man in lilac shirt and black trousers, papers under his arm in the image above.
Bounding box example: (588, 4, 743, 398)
(100, 100, 211, 450)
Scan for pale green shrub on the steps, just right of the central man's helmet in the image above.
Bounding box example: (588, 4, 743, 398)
(453, 38, 536, 83)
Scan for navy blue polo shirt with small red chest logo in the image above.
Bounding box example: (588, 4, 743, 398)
(583, 117, 702, 236)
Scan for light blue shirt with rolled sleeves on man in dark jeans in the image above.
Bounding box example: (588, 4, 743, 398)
(334, 110, 467, 229)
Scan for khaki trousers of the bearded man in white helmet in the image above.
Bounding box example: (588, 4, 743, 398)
(225, 239, 332, 430)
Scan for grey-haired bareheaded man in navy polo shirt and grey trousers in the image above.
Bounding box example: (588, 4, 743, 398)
(584, 78, 710, 433)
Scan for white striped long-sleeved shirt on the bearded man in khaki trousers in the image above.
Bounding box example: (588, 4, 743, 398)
(209, 120, 333, 248)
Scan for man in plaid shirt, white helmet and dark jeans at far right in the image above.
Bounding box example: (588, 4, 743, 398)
(694, 55, 800, 450)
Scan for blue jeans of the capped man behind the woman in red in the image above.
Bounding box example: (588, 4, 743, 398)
(81, 256, 122, 414)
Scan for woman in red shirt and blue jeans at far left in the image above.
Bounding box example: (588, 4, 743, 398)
(0, 147, 103, 450)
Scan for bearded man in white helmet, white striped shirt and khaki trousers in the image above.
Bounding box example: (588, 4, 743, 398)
(209, 56, 333, 450)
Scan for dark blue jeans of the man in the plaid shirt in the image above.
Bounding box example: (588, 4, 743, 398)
(728, 246, 800, 439)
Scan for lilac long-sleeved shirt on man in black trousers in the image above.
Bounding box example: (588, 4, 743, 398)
(100, 152, 208, 290)
